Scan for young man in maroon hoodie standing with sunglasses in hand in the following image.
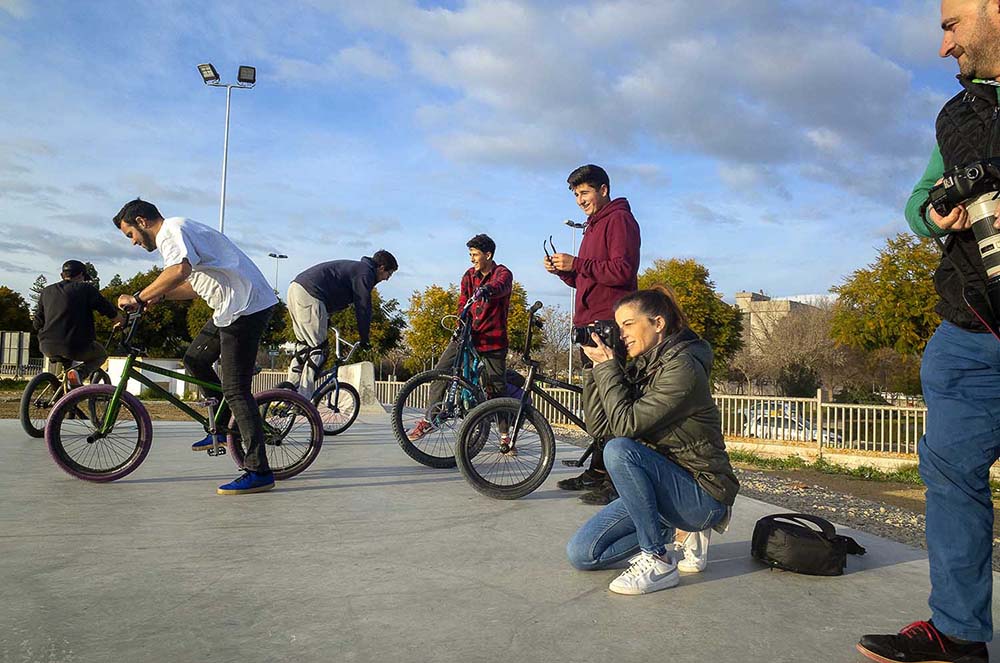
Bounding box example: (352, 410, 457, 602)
(544, 164, 640, 504)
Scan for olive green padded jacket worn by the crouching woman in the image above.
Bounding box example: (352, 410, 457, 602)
(583, 329, 740, 506)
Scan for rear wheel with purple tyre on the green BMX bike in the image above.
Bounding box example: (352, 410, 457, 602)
(229, 389, 323, 479)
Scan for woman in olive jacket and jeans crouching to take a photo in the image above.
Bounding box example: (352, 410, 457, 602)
(566, 286, 739, 594)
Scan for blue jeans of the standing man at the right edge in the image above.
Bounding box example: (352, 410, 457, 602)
(918, 321, 1000, 642)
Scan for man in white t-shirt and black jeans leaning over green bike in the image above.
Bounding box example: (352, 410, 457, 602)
(114, 198, 278, 495)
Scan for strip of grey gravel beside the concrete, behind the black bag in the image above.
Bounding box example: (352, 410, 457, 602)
(736, 469, 1000, 571)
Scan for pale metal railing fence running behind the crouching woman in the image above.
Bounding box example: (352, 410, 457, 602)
(375, 381, 927, 454)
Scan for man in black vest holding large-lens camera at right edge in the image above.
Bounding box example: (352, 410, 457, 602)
(858, 5, 1000, 663)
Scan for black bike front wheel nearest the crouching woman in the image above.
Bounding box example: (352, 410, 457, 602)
(455, 398, 556, 500)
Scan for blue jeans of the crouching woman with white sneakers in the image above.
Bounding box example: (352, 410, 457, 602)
(566, 437, 726, 571)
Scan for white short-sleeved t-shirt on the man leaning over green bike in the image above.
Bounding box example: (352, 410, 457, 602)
(156, 216, 278, 327)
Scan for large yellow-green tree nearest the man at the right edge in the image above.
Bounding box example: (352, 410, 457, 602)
(831, 233, 941, 354)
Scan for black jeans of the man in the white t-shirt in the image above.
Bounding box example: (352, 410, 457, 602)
(184, 307, 274, 472)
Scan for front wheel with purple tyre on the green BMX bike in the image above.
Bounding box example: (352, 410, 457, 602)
(45, 384, 153, 481)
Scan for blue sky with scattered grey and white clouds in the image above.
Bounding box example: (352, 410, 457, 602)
(0, 0, 957, 314)
